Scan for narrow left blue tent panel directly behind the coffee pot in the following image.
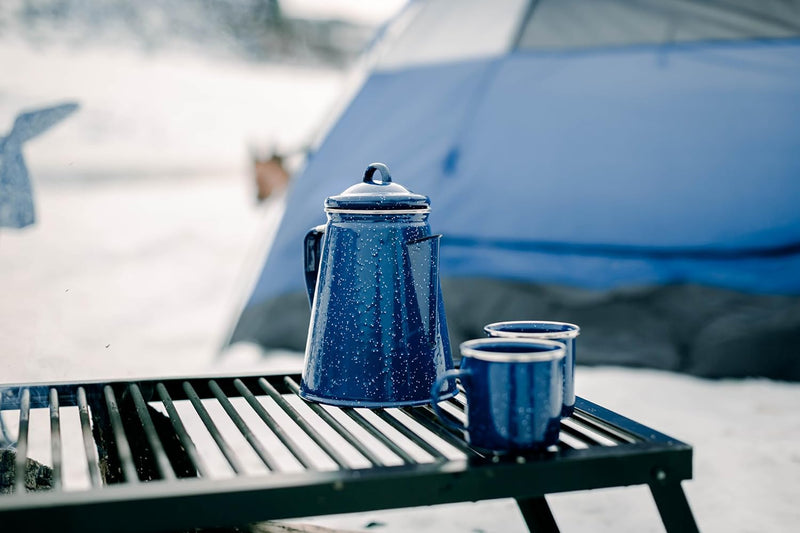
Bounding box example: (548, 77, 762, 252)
(250, 57, 494, 303)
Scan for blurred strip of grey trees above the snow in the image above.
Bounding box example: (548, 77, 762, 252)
(0, 0, 374, 66)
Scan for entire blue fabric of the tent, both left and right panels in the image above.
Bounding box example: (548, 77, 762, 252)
(250, 40, 800, 303)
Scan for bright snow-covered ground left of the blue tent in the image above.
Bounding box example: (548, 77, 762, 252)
(0, 33, 343, 381)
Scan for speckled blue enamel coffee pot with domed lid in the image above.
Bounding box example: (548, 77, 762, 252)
(300, 163, 456, 407)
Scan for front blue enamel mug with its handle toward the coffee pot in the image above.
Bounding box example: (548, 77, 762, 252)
(431, 338, 566, 453)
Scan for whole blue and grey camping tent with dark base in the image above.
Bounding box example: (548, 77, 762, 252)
(231, 0, 800, 379)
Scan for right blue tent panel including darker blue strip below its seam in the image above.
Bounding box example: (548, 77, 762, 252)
(432, 41, 800, 294)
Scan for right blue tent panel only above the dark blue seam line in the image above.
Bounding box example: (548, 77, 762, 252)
(443, 41, 800, 251)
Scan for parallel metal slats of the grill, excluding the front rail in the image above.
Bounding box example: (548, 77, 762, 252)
(0, 370, 642, 492)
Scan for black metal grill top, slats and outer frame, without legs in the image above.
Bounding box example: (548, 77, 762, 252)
(0, 375, 691, 531)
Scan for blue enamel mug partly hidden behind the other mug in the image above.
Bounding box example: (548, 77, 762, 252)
(483, 320, 581, 416)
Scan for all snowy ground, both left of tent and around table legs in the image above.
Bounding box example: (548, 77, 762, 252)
(0, 22, 800, 533)
